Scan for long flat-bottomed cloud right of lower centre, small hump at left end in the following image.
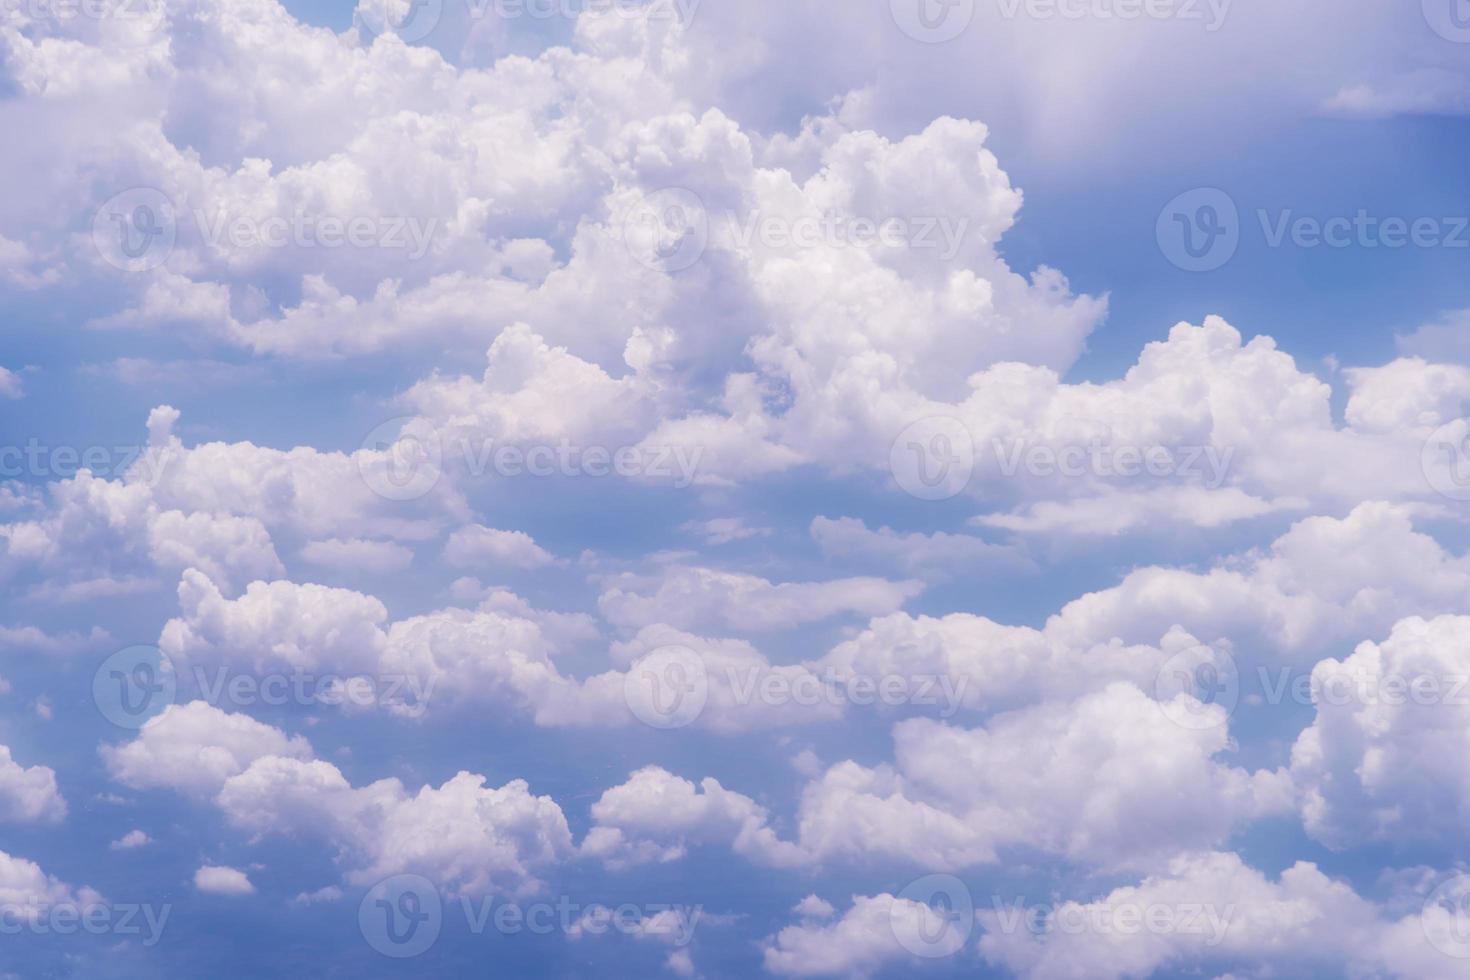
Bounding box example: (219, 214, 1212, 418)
(584, 683, 1294, 870)
